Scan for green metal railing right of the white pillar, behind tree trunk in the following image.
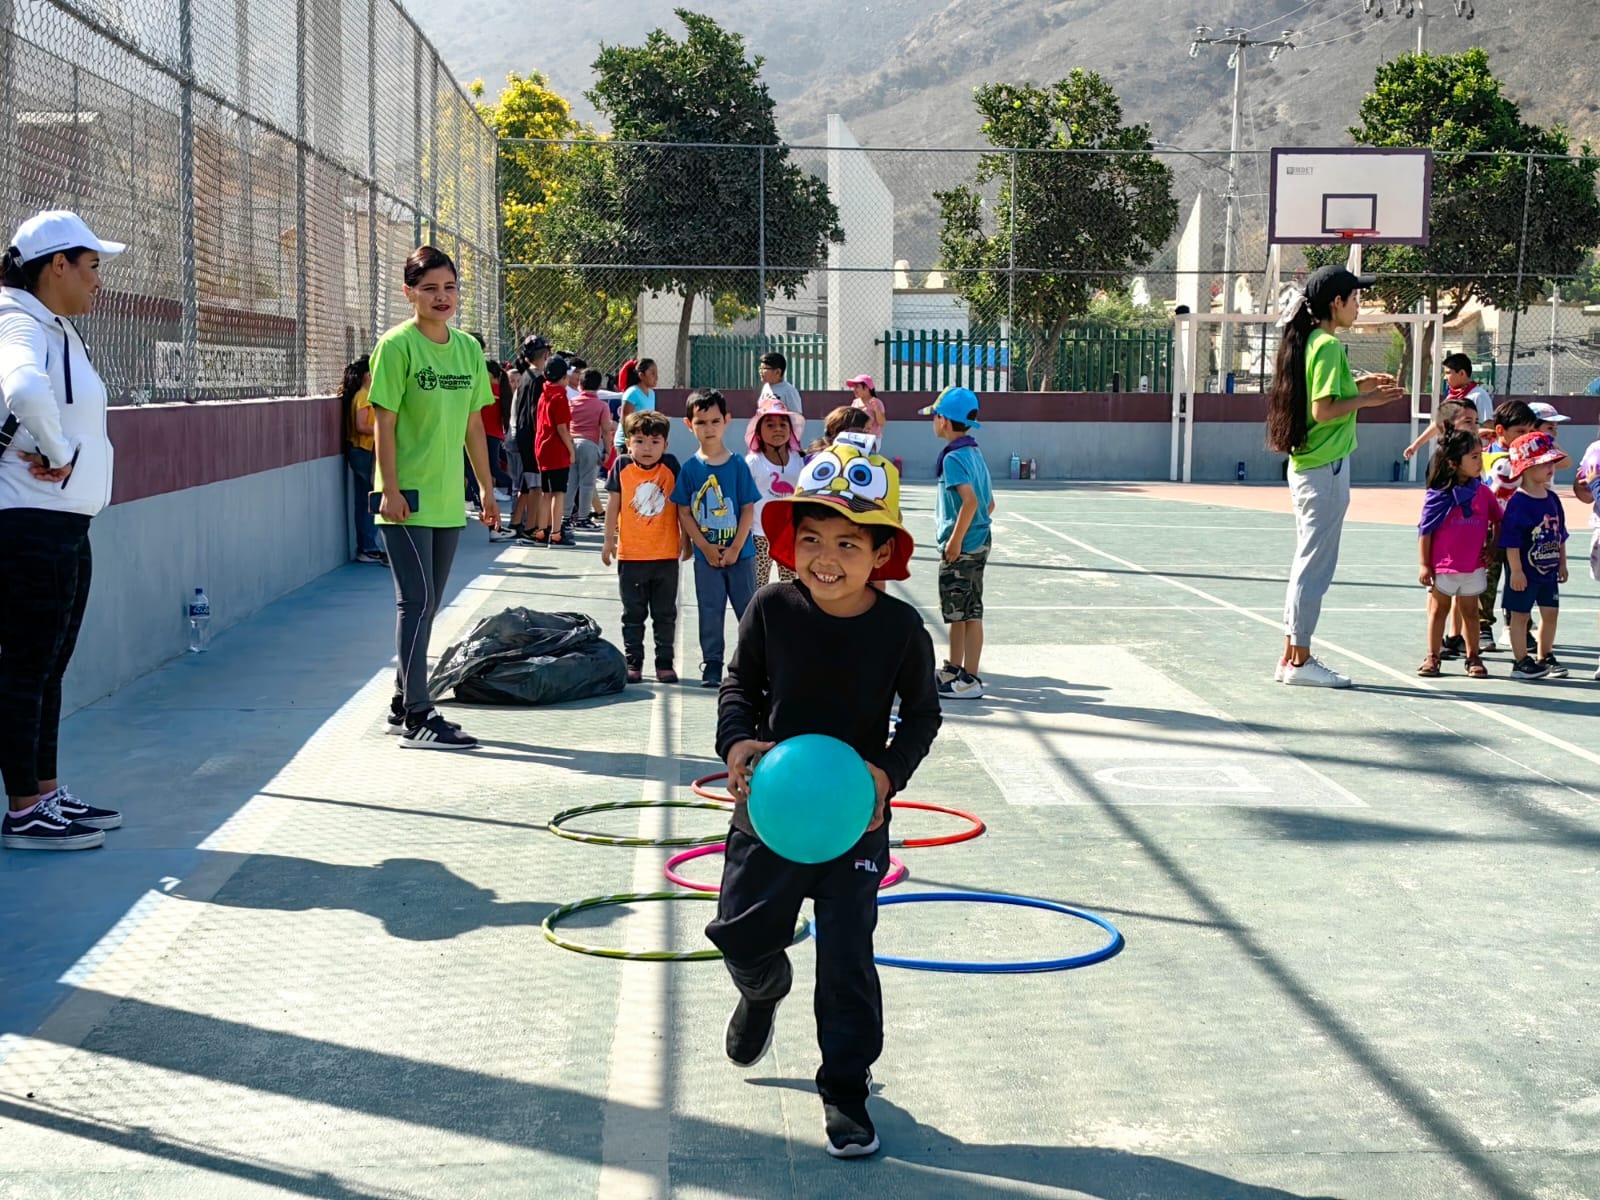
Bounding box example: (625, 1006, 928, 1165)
(882, 325, 1173, 392)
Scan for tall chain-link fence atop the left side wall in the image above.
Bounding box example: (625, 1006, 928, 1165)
(0, 0, 501, 403)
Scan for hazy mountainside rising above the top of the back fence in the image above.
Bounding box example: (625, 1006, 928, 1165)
(414, 0, 1600, 155)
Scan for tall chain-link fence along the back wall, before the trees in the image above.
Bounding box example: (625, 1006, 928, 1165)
(501, 136, 1600, 400)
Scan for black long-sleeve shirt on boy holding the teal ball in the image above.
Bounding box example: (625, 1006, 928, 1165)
(717, 582, 941, 834)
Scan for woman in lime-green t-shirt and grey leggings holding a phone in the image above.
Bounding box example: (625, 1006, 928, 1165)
(370, 246, 499, 750)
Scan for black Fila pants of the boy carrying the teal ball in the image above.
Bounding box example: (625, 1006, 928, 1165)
(706, 826, 890, 1104)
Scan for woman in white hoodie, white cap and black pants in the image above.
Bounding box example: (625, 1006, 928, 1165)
(0, 211, 123, 850)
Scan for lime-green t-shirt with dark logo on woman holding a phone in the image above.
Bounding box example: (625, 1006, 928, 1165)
(370, 322, 494, 530)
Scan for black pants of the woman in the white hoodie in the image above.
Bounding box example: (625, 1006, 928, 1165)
(0, 509, 91, 795)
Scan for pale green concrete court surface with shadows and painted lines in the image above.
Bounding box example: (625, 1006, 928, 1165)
(0, 485, 1600, 1200)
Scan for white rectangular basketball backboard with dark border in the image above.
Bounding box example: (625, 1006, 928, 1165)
(1267, 147, 1434, 246)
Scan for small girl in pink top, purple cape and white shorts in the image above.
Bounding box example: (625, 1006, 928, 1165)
(1416, 429, 1502, 678)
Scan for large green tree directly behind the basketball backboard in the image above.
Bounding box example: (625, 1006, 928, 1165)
(1307, 50, 1600, 385)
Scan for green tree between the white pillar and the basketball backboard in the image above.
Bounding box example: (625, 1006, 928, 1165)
(934, 69, 1178, 389)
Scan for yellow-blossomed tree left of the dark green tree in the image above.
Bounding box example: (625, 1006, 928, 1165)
(470, 70, 638, 362)
